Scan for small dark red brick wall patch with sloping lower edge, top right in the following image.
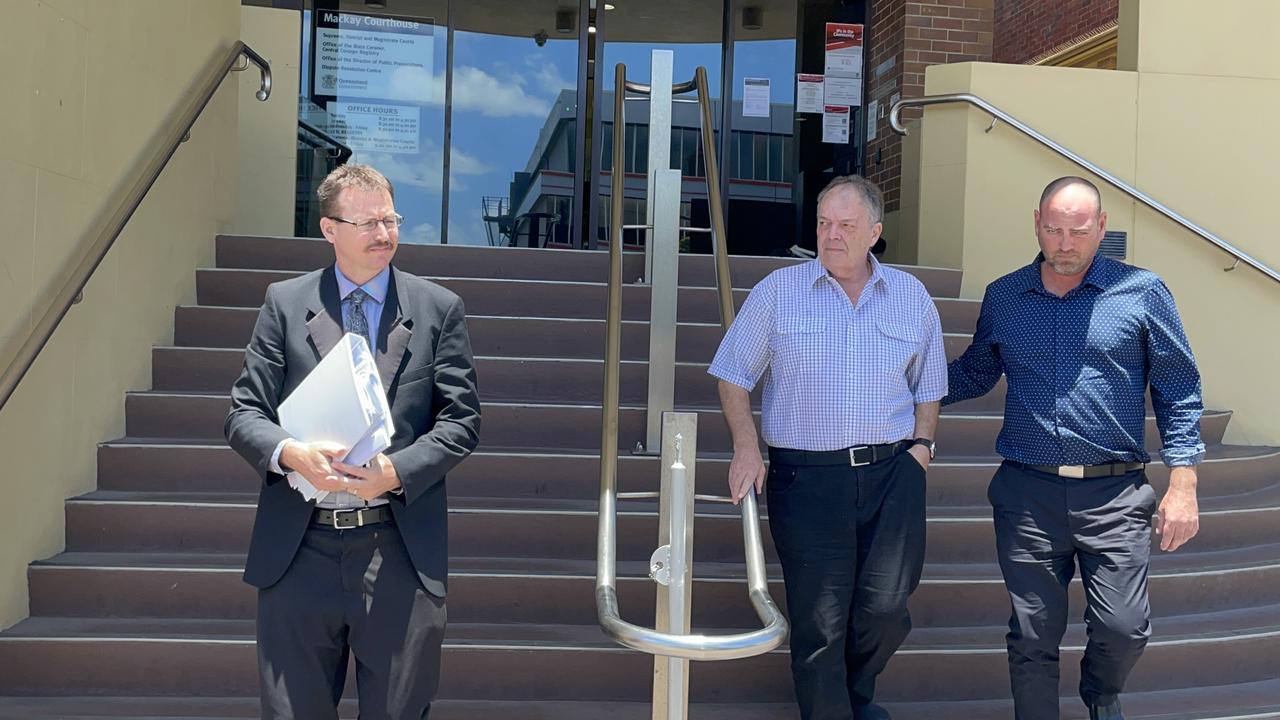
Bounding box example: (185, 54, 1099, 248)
(992, 0, 1120, 63)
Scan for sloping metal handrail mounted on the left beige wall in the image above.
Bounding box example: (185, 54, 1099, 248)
(0, 41, 271, 409)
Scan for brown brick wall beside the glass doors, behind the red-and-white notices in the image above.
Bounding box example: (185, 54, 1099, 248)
(859, 0, 993, 210)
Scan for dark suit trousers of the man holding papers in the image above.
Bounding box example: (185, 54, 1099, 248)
(257, 523, 445, 720)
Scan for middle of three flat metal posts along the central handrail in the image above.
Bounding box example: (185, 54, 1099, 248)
(645, 168, 681, 452)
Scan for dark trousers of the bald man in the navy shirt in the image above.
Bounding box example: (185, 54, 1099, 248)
(987, 462, 1156, 720)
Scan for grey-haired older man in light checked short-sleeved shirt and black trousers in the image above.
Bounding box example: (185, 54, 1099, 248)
(709, 176, 947, 720)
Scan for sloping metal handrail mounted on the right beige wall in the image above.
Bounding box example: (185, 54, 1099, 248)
(888, 92, 1280, 282)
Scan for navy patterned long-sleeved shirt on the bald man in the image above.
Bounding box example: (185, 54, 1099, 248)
(942, 255, 1204, 466)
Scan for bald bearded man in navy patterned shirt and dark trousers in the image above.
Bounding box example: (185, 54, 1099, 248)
(942, 177, 1204, 720)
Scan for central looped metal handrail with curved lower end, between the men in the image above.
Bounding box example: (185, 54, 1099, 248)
(595, 63, 787, 660)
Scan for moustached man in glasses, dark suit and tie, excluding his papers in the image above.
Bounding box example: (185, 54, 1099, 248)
(225, 165, 480, 720)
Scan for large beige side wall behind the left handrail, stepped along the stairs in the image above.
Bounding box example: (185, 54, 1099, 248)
(0, 0, 241, 628)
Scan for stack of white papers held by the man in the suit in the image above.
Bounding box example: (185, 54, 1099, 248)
(279, 333, 394, 501)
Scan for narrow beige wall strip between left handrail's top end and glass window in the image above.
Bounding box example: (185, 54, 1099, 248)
(232, 5, 302, 236)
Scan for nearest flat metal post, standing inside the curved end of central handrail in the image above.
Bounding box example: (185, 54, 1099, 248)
(653, 413, 698, 720)
